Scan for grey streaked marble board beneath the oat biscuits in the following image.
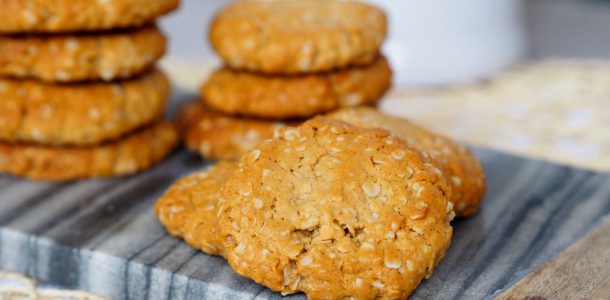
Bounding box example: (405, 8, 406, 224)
(0, 92, 610, 299)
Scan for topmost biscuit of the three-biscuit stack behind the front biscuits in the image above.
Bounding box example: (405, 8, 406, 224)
(210, 0, 387, 74)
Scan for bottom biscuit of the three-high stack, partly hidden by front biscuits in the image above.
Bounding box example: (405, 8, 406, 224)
(178, 101, 294, 160)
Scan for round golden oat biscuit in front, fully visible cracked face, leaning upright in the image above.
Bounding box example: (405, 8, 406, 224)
(219, 118, 453, 299)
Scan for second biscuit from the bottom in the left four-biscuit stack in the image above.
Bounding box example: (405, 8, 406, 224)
(0, 71, 169, 145)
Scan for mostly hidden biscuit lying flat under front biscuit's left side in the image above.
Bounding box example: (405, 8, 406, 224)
(155, 161, 237, 255)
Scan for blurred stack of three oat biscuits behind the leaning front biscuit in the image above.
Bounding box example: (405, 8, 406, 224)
(179, 0, 392, 159)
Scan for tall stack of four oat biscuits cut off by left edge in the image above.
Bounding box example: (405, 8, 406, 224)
(0, 0, 178, 181)
